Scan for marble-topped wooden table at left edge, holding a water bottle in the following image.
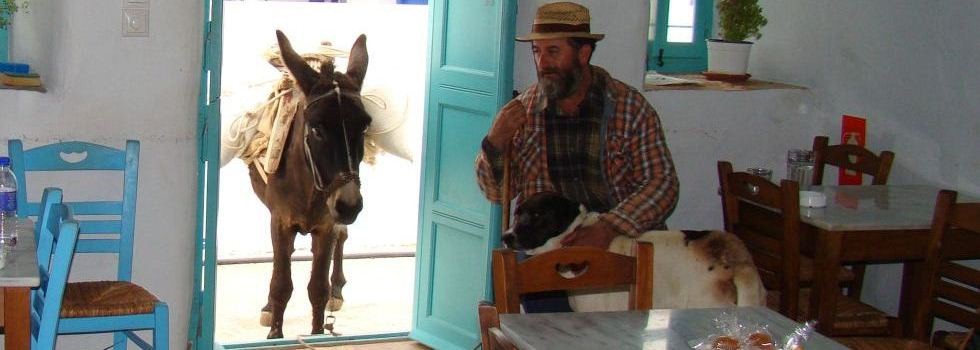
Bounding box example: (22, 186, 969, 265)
(0, 219, 41, 349)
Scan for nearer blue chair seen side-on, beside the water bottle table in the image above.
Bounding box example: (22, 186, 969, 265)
(31, 188, 78, 350)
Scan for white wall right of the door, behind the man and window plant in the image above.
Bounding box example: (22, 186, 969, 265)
(515, 0, 980, 320)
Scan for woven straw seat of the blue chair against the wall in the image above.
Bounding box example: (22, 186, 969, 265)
(61, 281, 159, 318)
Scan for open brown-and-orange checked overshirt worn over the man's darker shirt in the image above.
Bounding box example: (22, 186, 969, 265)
(476, 66, 679, 237)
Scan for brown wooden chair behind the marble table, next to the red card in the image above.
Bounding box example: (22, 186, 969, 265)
(803, 136, 895, 299)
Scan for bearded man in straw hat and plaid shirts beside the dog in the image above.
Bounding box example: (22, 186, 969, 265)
(476, 2, 679, 249)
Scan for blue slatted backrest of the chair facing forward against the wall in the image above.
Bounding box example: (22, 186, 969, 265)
(8, 140, 140, 281)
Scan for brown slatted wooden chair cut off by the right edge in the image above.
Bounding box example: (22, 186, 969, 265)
(837, 190, 980, 349)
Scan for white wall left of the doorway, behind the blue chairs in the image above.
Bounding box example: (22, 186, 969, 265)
(0, 0, 203, 349)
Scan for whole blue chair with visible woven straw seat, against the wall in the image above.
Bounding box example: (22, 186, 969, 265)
(8, 140, 169, 350)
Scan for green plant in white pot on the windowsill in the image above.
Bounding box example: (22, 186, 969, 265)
(707, 0, 768, 78)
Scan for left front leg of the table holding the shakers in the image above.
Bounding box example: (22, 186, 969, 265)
(806, 230, 841, 335)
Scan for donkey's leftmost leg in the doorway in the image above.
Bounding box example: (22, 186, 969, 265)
(262, 221, 296, 339)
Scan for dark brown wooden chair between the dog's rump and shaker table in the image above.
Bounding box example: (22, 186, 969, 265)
(718, 161, 898, 335)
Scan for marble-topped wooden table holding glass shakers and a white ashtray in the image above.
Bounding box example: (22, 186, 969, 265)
(740, 185, 980, 334)
